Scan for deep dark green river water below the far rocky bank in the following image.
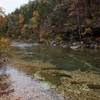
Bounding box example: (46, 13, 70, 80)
(11, 42, 100, 71)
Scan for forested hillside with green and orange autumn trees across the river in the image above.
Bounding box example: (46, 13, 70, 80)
(0, 0, 100, 47)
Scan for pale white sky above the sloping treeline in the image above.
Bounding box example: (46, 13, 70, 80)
(0, 0, 29, 14)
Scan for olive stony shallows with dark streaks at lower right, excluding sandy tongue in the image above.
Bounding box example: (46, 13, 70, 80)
(34, 69, 100, 100)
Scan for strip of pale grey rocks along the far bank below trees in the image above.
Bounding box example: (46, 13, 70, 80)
(47, 40, 100, 50)
